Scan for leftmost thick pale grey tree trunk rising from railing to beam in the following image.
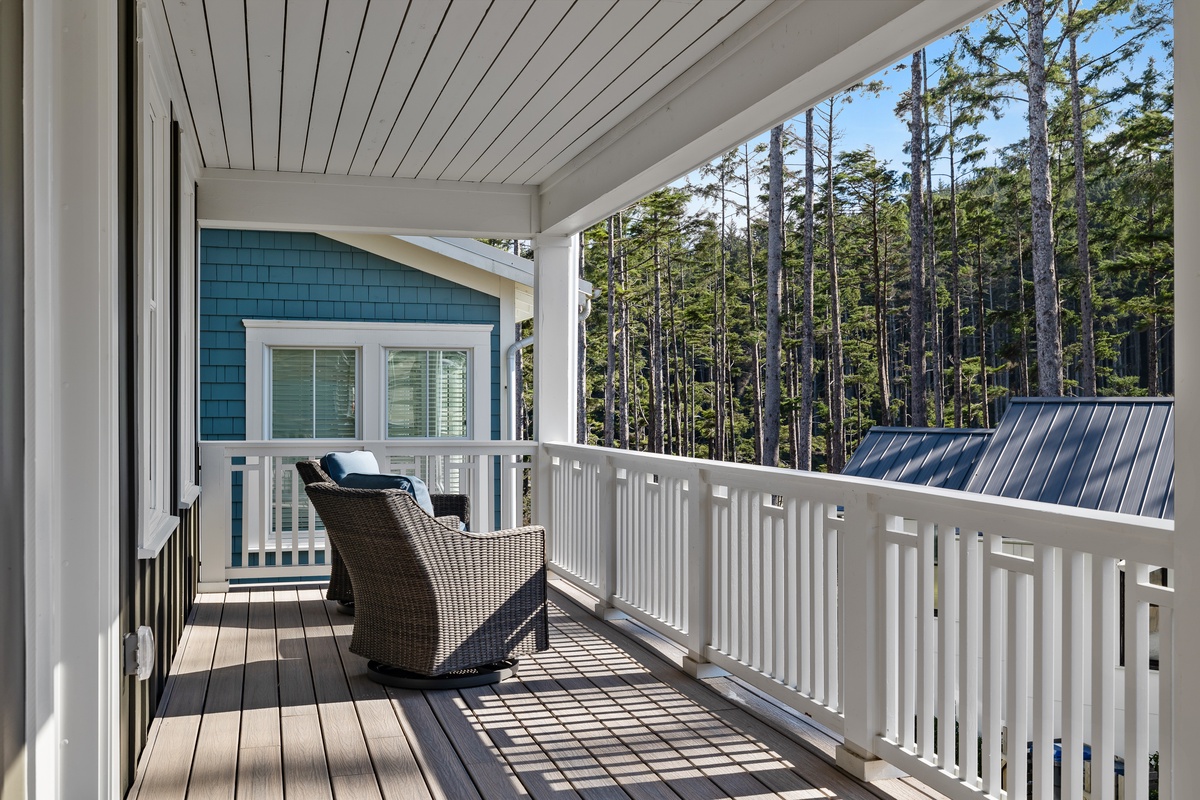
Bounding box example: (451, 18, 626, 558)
(762, 125, 784, 467)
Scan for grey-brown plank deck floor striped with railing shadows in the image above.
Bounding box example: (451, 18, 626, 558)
(130, 588, 937, 800)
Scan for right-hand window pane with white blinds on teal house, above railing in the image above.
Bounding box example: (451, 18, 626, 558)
(388, 350, 470, 438)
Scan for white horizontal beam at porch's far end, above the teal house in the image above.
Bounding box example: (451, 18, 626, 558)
(197, 169, 538, 239)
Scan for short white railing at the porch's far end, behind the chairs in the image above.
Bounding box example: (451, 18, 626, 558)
(200, 439, 538, 591)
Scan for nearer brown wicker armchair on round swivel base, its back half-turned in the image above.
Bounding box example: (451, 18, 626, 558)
(305, 482, 548, 688)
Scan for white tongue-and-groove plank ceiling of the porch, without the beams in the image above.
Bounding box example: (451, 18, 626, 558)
(162, 0, 763, 185)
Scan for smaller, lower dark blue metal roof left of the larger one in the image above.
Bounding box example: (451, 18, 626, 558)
(841, 427, 992, 489)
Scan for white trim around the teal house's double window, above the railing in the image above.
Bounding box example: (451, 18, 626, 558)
(241, 319, 492, 441)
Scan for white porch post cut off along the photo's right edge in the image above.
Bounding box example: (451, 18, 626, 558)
(1172, 2, 1200, 798)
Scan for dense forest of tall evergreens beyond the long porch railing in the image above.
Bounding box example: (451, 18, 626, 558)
(508, 0, 1174, 471)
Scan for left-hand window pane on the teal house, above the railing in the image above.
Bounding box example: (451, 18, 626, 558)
(271, 348, 359, 439)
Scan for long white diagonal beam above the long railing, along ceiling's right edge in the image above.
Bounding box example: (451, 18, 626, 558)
(540, 0, 1001, 234)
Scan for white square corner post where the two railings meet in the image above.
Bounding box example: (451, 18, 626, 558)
(533, 234, 580, 537)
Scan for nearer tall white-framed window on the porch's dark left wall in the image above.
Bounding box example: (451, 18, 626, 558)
(134, 17, 179, 558)
